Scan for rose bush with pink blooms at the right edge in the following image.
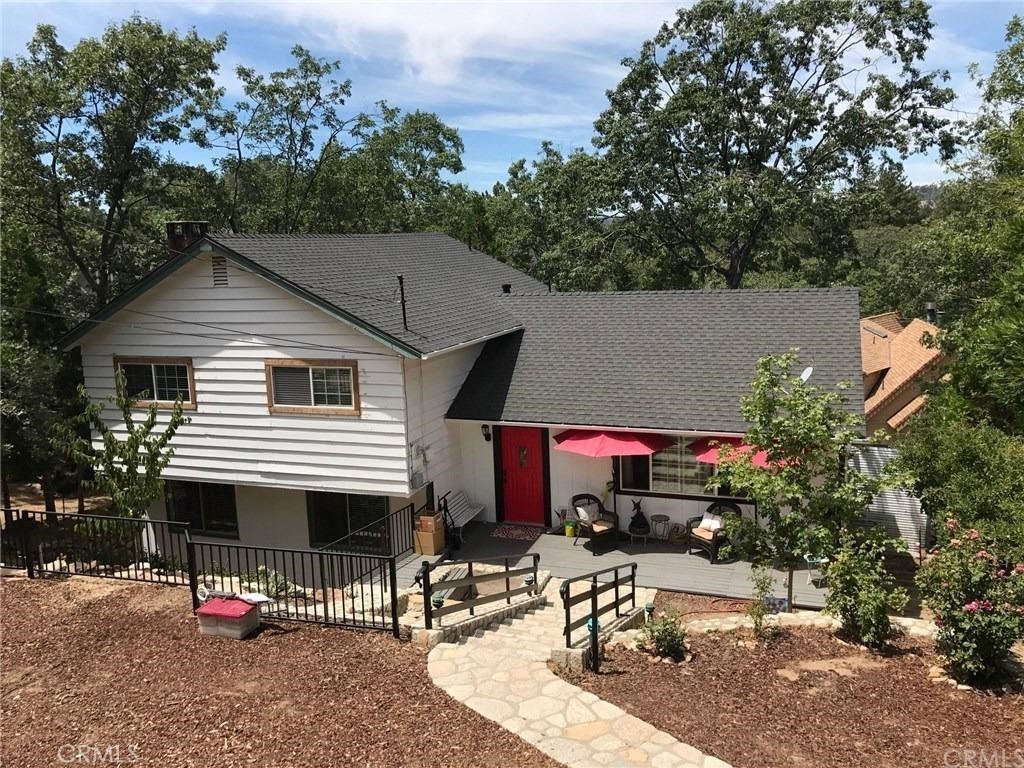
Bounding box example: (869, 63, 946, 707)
(918, 519, 1024, 682)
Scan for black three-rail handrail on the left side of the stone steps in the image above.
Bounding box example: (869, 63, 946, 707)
(420, 552, 541, 630)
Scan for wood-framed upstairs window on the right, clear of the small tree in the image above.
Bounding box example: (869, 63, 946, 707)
(265, 359, 359, 416)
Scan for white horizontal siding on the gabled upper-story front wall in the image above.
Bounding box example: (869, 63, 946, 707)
(82, 256, 410, 496)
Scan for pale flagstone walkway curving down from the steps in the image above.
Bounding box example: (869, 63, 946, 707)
(428, 580, 728, 768)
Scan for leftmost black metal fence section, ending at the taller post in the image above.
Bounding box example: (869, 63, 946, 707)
(0, 509, 189, 586)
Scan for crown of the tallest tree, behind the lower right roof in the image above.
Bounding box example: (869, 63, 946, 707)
(595, 0, 952, 288)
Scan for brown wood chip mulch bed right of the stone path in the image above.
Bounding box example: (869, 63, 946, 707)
(572, 629, 1024, 768)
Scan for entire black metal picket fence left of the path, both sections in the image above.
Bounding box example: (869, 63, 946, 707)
(0, 509, 398, 637)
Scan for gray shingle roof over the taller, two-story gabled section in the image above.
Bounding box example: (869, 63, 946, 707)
(209, 232, 548, 354)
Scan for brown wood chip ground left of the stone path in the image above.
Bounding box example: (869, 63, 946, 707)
(0, 577, 557, 768)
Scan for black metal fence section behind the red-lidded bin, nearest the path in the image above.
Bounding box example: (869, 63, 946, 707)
(193, 542, 398, 637)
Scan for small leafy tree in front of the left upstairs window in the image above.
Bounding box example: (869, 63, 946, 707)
(54, 369, 190, 517)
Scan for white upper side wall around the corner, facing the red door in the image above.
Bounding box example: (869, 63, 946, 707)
(406, 344, 482, 496)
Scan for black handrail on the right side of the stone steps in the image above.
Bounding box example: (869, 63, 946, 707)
(558, 562, 637, 672)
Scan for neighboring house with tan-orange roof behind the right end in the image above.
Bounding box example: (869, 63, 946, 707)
(860, 312, 947, 434)
